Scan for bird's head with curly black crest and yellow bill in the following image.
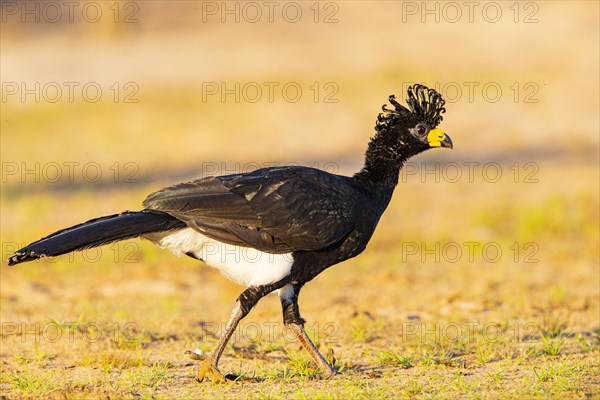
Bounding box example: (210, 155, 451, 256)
(375, 84, 453, 160)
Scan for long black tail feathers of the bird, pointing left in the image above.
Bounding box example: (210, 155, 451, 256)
(8, 210, 186, 265)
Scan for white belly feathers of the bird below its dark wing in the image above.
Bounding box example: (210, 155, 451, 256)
(149, 228, 294, 287)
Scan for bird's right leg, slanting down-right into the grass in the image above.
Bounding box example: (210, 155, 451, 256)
(279, 284, 336, 379)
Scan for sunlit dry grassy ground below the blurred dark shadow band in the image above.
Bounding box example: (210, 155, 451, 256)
(0, 156, 600, 398)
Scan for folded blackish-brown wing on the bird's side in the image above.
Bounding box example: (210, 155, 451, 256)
(144, 167, 359, 253)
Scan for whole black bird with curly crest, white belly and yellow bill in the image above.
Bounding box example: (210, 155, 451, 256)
(8, 85, 452, 382)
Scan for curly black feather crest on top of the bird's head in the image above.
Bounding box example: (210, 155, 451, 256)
(375, 84, 446, 130)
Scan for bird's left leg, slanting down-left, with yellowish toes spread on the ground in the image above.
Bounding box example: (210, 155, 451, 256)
(185, 286, 273, 383)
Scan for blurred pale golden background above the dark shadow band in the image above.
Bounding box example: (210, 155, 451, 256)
(1, 1, 598, 172)
